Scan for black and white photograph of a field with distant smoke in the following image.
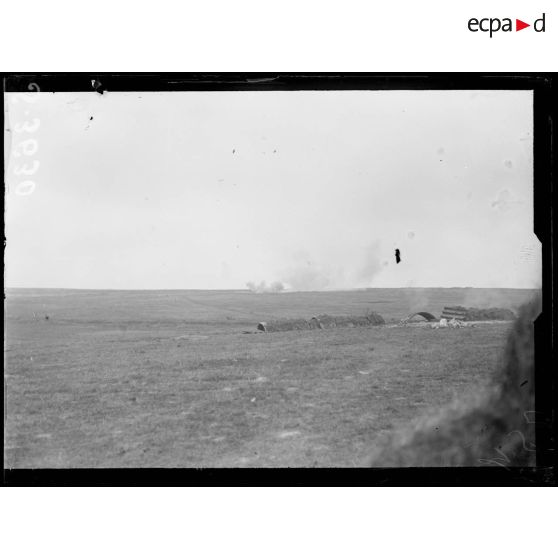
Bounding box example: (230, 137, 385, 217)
(4, 75, 543, 471)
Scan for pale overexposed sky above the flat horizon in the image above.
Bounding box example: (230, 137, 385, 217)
(4, 91, 541, 290)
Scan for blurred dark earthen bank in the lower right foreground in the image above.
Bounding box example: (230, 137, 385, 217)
(371, 299, 541, 467)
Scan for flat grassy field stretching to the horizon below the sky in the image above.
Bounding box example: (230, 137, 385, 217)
(4, 289, 533, 468)
